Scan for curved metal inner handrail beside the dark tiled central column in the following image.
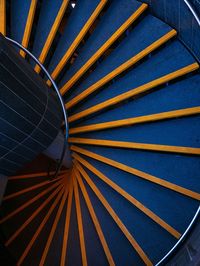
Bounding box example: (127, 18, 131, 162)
(5, 36, 69, 177)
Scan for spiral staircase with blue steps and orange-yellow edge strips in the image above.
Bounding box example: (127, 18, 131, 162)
(0, 0, 200, 266)
